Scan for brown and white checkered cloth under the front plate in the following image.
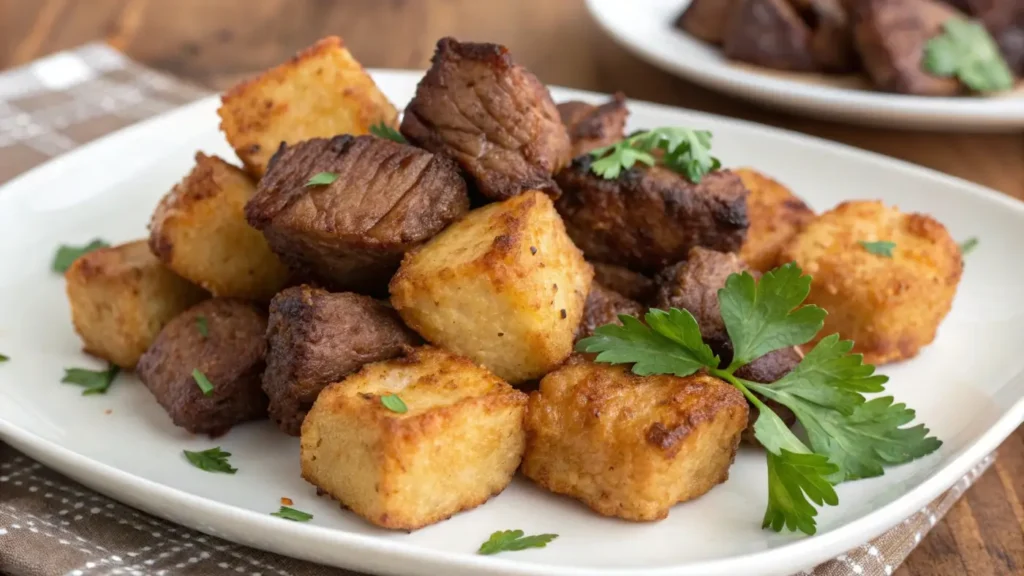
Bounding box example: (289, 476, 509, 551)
(0, 44, 993, 576)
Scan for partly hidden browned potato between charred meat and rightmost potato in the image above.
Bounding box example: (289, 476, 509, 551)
(736, 168, 814, 272)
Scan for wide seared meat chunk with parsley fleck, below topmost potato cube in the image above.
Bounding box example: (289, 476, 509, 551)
(246, 135, 469, 293)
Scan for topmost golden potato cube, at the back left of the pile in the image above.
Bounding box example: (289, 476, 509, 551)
(217, 36, 398, 177)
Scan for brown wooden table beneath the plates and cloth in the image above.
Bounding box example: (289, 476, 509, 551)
(0, 0, 1024, 576)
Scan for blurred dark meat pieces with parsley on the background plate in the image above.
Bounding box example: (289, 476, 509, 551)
(675, 0, 1024, 96)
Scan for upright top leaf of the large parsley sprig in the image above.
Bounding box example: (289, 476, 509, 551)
(718, 262, 825, 368)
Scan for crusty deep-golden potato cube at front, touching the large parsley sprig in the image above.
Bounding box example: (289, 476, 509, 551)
(522, 356, 748, 522)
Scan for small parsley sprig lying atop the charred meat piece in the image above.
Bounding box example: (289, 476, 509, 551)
(590, 127, 722, 183)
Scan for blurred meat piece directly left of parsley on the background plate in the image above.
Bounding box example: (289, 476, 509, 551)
(854, 0, 963, 96)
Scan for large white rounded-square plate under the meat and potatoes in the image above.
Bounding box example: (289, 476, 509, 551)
(0, 72, 1024, 576)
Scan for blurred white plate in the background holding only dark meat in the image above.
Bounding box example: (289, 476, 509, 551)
(587, 0, 1024, 131)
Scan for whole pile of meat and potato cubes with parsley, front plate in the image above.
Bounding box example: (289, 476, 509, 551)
(61, 38, 962, 541)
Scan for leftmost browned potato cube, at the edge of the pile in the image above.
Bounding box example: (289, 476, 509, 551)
(65, 240, 207, 369)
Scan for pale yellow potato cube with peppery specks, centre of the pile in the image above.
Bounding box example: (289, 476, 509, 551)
(390, 191, 594, 383)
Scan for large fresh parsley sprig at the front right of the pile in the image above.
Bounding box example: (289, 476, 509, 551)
(577, 263, 942, 534)
